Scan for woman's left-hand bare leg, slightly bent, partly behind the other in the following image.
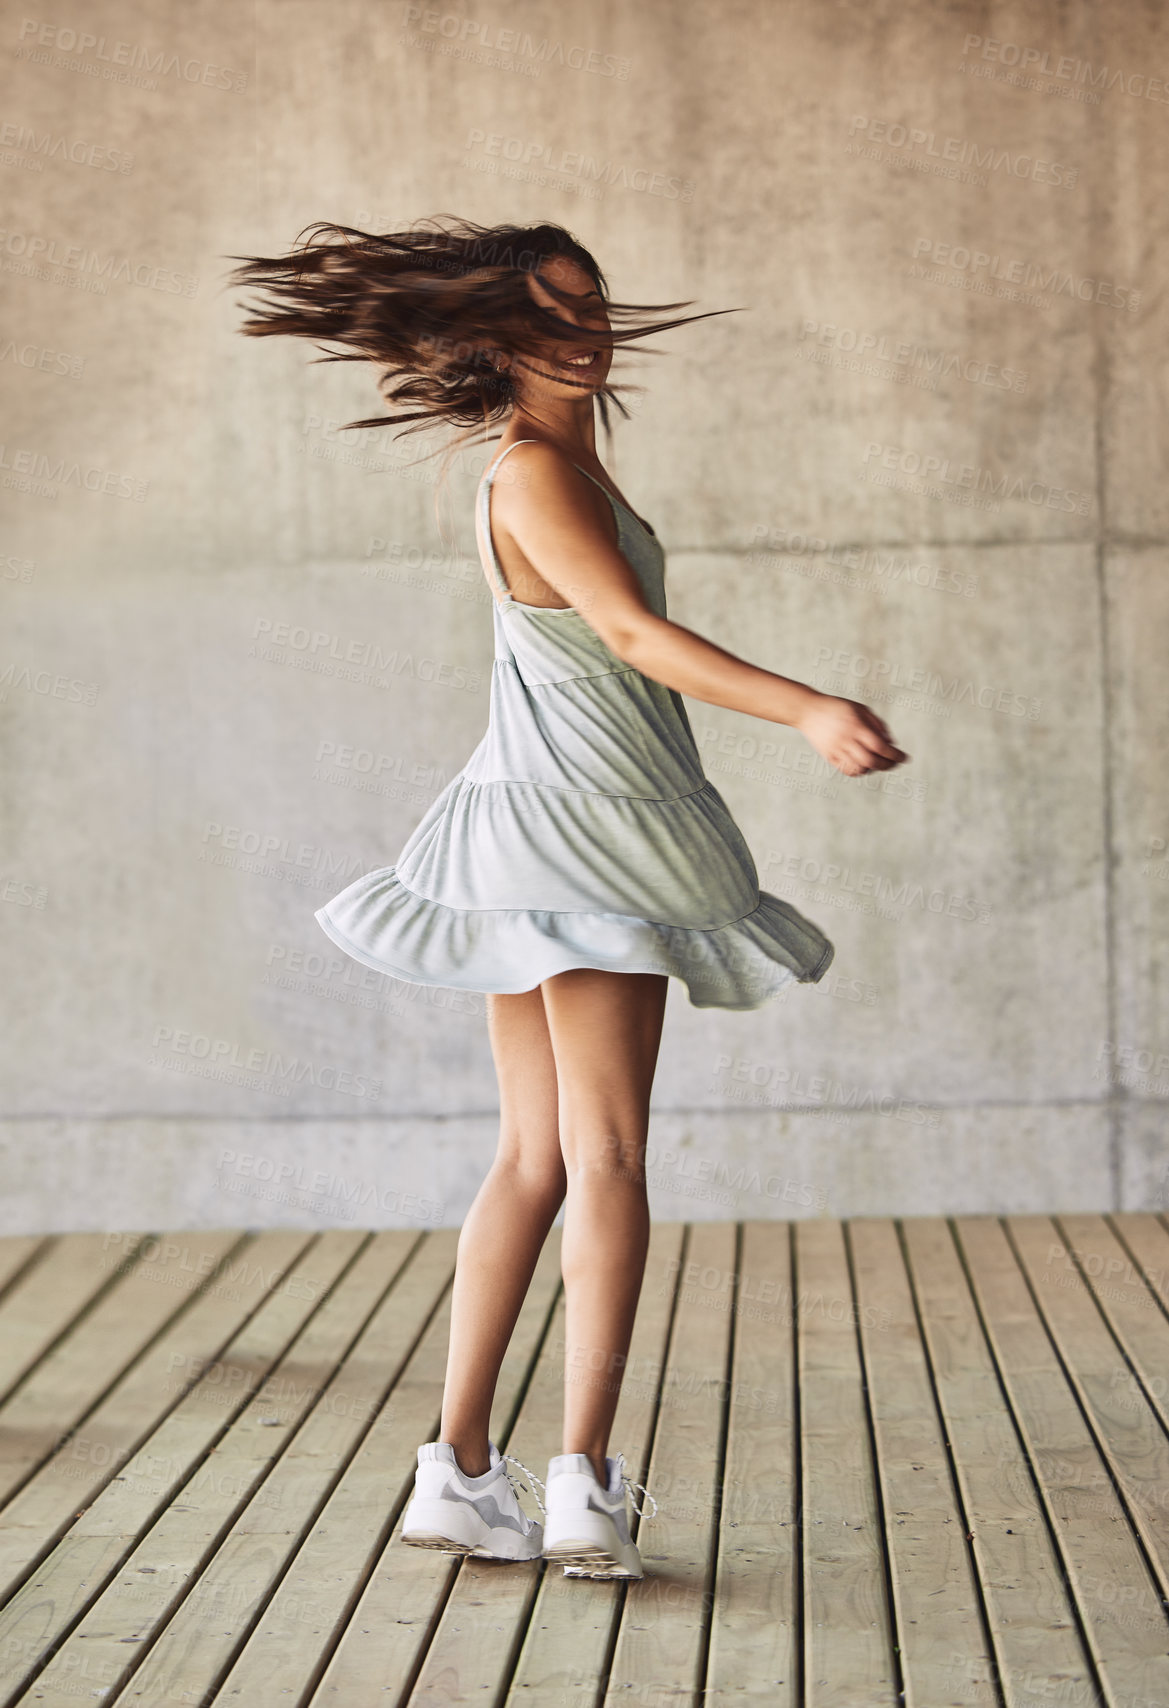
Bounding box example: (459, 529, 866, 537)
(439, 986, 566, 1477)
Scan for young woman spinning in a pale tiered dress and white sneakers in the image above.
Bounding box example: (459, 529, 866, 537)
(232, 220, 908, 1576)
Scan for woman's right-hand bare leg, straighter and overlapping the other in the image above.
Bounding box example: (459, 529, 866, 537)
(542, 967, 668, 1483)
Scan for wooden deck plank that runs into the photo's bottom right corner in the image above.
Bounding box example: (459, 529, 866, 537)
(955, 1216, 1169, 1708)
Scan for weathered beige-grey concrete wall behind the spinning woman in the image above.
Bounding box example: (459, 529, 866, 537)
(0, 0, 1169, 1231)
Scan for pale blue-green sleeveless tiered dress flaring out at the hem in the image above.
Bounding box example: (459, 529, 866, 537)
(314, 439, 834, 1009)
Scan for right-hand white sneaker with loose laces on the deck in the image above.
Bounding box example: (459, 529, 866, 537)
(543, 1454, 658, 1578)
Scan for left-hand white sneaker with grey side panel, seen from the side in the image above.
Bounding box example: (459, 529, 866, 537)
(402, 1442, 543, 1559)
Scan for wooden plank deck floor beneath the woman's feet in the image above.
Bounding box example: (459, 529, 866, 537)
(0, 1213, 1169, 1708)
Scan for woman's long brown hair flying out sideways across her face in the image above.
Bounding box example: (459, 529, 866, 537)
(226, 215, 735, 464)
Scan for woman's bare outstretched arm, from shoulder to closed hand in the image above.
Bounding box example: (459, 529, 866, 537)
(491, 444, 909, 777)
